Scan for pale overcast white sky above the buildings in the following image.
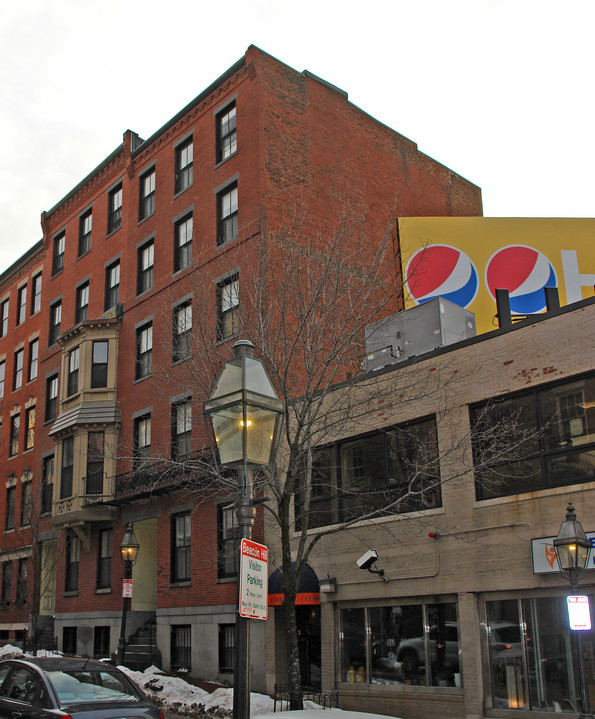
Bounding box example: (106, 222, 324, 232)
(0, 0, 595, 271)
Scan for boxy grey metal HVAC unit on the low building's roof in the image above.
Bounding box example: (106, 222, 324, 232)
(364, 297, 477, 372)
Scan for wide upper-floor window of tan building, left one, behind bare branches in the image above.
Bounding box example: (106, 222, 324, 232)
(295, 418, 442, 528)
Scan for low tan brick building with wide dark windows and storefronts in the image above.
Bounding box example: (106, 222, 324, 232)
(267, 297, 595, 719)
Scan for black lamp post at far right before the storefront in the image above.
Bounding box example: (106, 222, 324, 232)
(554, 502, 593, 719)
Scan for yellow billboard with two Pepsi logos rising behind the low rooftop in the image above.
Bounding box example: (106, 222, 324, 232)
(399, 217, 595, 333)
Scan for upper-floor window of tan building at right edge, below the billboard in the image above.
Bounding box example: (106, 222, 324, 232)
(470, 375, 595, 500)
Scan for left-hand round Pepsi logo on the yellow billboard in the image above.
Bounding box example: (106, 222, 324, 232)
(405, 245, 479, 307)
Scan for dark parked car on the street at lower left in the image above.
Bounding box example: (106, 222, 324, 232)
(0, 657, 165, 719)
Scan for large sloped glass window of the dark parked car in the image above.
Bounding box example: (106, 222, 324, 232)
(48, 671, 141, 706)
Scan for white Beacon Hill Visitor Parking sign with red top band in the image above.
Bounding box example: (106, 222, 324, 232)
(238, 539, 269, 619)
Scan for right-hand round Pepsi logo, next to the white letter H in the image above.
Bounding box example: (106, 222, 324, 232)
(485, 245, 558, 315)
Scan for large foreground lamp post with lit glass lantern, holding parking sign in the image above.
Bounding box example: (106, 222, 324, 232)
(204, 340, 284, 719)
